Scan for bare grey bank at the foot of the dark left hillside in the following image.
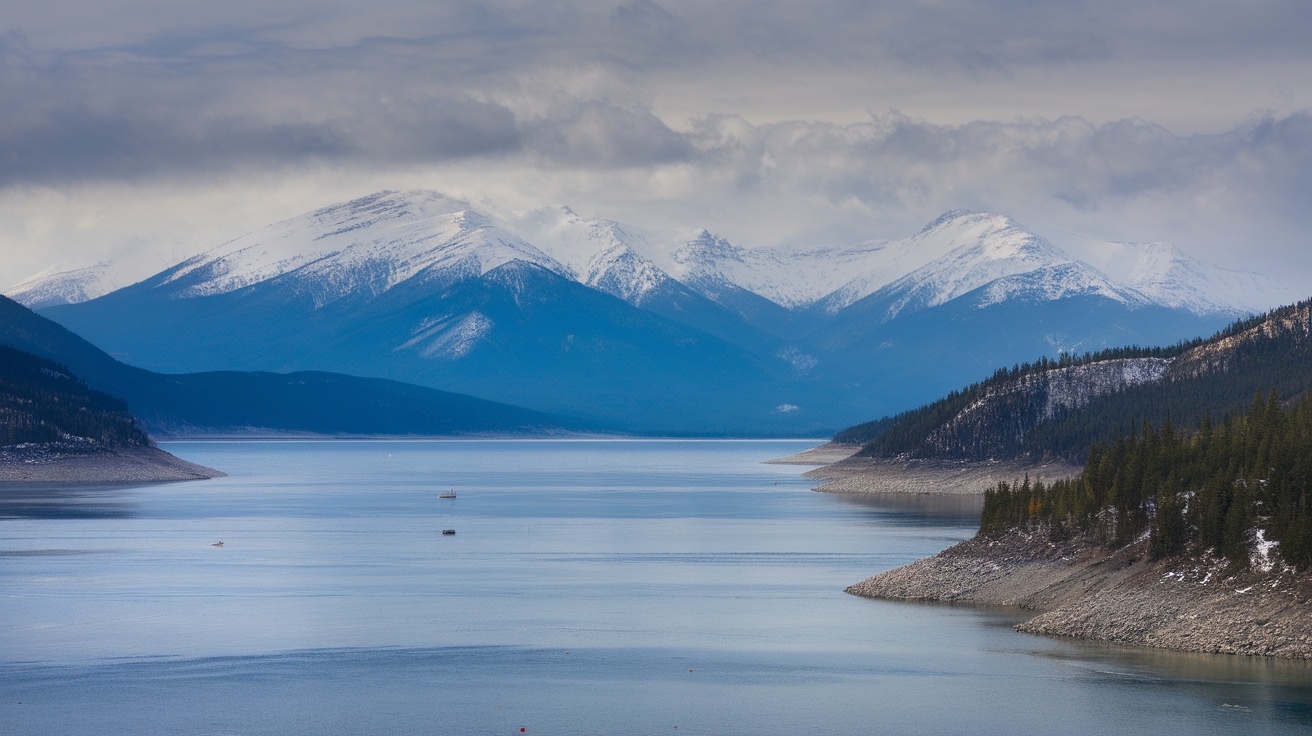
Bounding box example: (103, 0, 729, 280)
(0, 446, 224, 483)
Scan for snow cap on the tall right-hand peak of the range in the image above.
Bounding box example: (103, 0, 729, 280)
(821, 210, 1148, 319)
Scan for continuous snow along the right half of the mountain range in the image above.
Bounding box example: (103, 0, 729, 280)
(670, 210, 1303, 319)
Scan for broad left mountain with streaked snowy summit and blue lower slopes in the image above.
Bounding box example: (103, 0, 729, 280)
(35, 193, 821, 434)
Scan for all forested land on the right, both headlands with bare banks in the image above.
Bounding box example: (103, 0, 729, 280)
(823, 300, 1312, 659)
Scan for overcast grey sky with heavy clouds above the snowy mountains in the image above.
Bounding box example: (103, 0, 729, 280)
(0, 0, 1312, 294)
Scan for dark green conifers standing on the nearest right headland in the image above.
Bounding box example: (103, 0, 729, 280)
(980, 391, 1312, 569)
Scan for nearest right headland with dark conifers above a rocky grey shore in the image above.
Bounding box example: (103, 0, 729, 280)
(848, 392, 1312, 659)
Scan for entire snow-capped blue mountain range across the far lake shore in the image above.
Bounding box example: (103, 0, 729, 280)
(9, 192, 1294, 436)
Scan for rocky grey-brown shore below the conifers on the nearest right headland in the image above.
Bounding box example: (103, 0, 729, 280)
(848, 531, 1312, 659)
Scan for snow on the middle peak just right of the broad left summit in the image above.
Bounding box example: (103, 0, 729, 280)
(506, 206, 670, 306)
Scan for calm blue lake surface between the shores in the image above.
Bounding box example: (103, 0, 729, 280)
(0, 441, 1312, 735)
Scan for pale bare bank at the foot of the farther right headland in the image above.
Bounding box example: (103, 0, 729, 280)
(803, 457, 1082, 495)
